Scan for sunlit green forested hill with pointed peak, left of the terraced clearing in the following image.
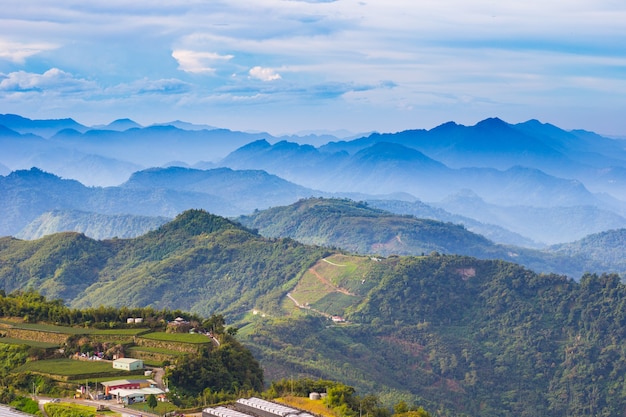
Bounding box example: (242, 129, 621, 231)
(0, 210, 327, 315)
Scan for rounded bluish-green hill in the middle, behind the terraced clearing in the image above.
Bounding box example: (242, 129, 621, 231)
(238, 198, 506, 257)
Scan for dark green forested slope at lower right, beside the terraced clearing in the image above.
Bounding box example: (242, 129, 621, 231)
(242, 256, 626, 416)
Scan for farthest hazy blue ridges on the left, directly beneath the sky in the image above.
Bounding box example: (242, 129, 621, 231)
(0, 114, 346, 186)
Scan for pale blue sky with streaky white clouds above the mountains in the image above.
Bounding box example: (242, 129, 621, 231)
(0, 0, 626, 136)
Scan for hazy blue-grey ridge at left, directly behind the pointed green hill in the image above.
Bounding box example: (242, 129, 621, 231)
(0, 168, 320, 236)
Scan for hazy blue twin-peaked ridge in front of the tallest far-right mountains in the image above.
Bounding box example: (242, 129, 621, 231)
(220, 140, 604, 207)
